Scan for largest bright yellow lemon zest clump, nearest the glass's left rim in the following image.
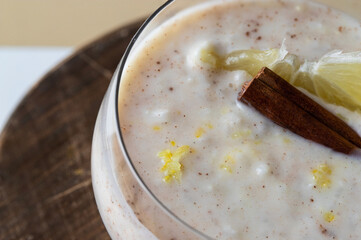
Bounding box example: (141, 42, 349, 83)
(158, 145, 190, 183)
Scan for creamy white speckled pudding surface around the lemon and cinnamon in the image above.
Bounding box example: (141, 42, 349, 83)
(119, 0, 361, 240)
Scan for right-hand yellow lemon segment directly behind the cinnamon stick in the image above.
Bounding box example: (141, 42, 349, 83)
(290, 51, 361, 110)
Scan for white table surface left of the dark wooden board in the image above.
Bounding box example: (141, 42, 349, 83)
(0, 47, 74, 132)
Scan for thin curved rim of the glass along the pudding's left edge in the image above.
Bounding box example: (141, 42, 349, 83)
(114, 0, 213, 240)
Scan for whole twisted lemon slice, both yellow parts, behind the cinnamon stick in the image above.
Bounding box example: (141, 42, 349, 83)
(200, 45, 361, 111)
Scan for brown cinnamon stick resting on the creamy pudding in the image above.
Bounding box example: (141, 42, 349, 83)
(238, 68, 361, 154)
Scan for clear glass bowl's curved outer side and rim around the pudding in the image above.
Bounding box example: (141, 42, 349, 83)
(91, 0, 361, 240)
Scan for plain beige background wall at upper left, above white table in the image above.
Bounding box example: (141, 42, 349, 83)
(0, 0, 165, 47)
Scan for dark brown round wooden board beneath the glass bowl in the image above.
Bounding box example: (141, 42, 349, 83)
(0, 21, 142, 240)
